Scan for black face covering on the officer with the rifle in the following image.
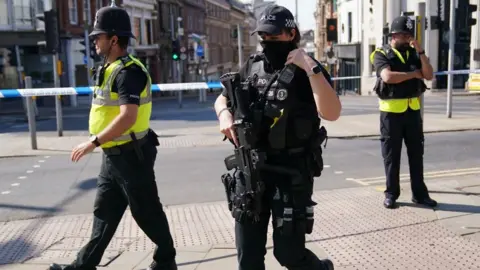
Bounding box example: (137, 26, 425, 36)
(260, 40, 297, 69)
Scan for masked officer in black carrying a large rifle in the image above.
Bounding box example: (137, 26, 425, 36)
(215, 5, 341, 270)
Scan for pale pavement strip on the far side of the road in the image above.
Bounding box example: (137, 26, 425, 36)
(0, 108, 480, 157)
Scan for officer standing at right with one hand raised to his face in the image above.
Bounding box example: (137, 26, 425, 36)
(370, 16, 437, 208)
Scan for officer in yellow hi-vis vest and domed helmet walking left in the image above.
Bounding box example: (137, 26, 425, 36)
(48, 3, 177, 270)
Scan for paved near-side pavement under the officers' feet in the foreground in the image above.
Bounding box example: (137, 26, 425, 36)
(0, 175, 480, 270)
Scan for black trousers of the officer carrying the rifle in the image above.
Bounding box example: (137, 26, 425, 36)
(235, 154, 324, 270)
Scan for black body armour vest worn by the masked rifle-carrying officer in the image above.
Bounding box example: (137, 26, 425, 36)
(248, 55, 320, 149)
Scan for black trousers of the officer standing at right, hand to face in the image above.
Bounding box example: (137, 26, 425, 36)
(380, 108, 429, 200)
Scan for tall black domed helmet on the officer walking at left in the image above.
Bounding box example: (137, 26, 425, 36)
(90, 6, 135, 38)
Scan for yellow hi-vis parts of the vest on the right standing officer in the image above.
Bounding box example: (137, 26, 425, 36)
(370, 48, 420, 113)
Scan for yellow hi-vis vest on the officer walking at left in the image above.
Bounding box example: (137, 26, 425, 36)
(89, 55, 152, 148)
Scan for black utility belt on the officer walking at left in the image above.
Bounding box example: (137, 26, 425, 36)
(102, 129, 160, 160)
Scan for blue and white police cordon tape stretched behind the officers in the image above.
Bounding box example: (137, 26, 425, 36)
(0, 69, 480, 98)
